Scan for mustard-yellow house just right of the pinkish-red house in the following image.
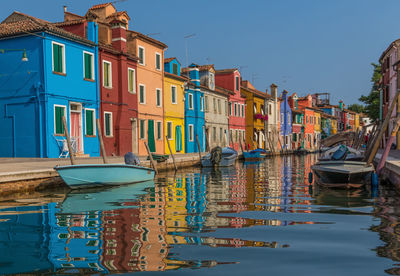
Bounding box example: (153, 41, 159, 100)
(240, 81, 267, 149)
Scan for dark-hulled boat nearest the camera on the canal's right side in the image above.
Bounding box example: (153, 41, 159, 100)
(311, 160, 374, 188)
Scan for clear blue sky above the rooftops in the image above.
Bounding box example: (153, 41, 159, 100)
(0, 0, 400, 104)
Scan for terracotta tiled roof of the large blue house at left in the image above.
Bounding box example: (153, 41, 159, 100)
(0, 11, 95, 45)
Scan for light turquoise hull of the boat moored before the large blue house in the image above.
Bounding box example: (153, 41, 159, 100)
(54, 164, 154, 189)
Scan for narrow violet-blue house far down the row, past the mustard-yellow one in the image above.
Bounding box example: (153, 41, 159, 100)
(280, 90, 292, 149)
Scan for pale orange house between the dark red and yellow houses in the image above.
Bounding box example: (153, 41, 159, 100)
(127, 30, 167, 155)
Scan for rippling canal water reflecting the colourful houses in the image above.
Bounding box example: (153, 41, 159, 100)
(0, 155, 400, 275)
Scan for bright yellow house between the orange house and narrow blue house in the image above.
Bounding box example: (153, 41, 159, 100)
(164, 58, 188, 154)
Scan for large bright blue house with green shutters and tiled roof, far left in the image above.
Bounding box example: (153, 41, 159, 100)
(0, 12, 99, 158)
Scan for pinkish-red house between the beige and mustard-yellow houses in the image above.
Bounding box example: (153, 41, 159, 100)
(215, 69, 246, 150)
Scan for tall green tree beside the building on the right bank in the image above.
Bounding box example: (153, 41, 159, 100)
(358, 63, 382, 120)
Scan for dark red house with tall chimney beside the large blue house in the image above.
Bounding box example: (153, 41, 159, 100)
(56, 3, 138, 156)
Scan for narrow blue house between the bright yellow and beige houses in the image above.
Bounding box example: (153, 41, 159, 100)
(182, 63, 206, 153)
